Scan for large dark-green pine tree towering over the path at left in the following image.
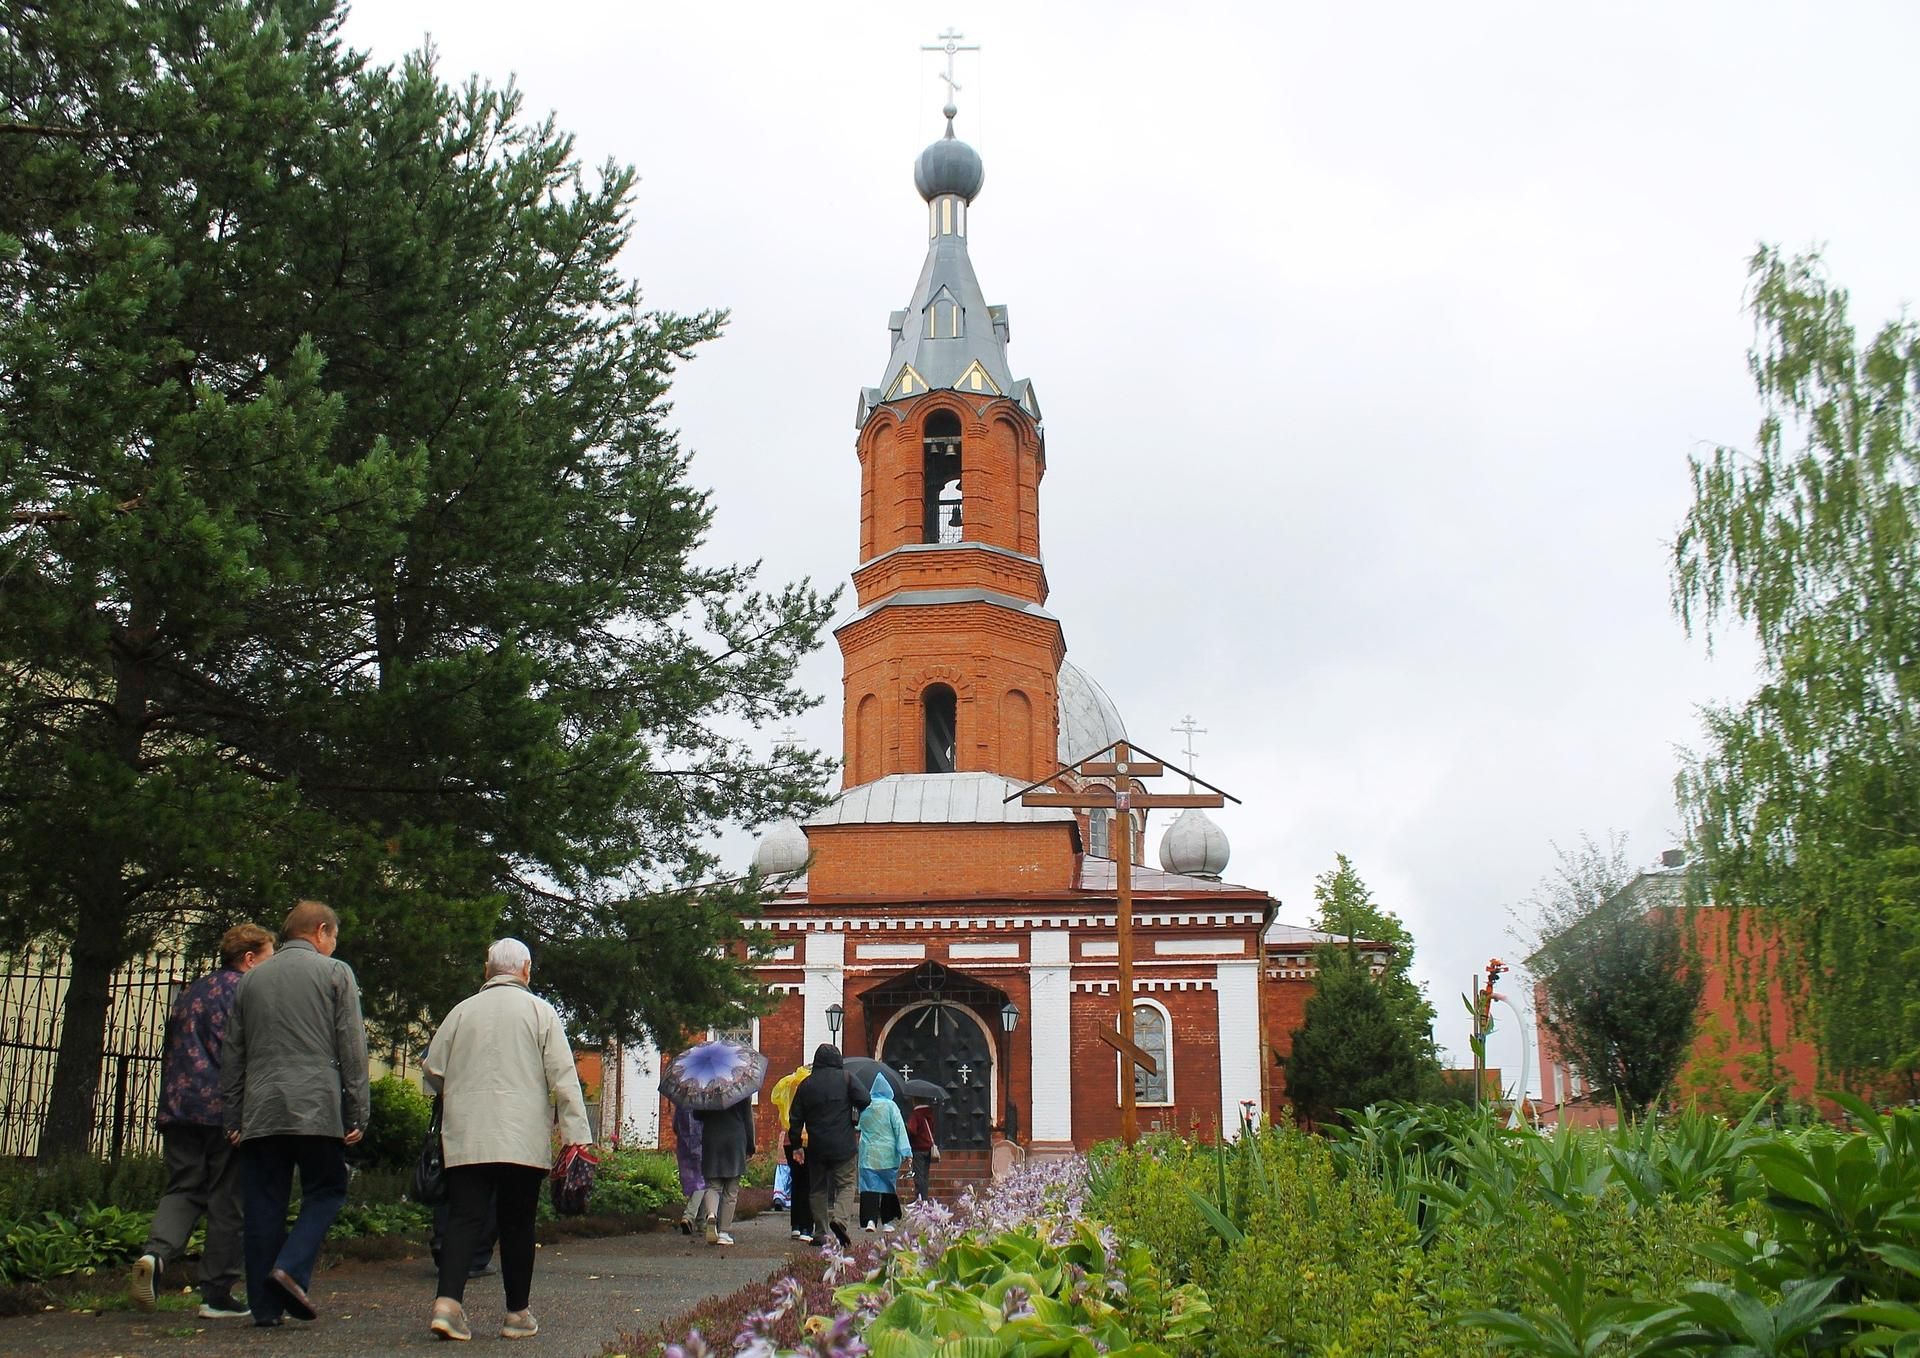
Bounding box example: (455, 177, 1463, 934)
(0, 0, 831, 1145)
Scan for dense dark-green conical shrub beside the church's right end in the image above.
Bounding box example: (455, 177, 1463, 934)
(1283, 943, 1438, 1122)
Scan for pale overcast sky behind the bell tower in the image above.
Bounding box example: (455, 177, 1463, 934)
(346, 0, 1920, 1083)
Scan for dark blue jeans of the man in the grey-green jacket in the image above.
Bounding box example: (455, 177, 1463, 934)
(240, 1137, 348, 1322)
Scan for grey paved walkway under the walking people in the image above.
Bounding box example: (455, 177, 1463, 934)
(0, 1212, 801, 1358)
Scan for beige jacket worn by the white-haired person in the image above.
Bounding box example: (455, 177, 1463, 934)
(420, 976, 593, 1168)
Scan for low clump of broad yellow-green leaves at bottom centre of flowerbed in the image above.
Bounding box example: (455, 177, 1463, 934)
(833, 1222, 1212, 1358)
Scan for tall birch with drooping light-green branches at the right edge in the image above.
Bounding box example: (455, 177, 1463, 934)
(1672, 248, 1920, 1089)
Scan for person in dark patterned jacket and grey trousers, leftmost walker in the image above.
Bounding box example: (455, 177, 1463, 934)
(127, 924, 273, 1320)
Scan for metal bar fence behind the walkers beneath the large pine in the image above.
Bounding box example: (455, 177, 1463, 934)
(0, 949, 209, 1160)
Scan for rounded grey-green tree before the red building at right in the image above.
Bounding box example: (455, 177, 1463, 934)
(1526, 834, 1705, 1112)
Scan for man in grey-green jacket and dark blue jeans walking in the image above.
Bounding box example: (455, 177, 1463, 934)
(221, 901, 367, 1325)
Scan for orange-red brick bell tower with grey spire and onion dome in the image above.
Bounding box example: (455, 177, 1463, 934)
(835, 117, 1066, 788)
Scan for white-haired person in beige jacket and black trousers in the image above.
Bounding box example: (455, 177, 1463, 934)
(422, 939, 593, 1339)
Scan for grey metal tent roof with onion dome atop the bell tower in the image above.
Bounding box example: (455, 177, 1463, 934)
(854, 113, 1041, 424)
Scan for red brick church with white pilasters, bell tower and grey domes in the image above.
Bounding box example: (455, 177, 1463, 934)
(605, 104, 1359, 1177)
